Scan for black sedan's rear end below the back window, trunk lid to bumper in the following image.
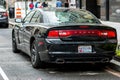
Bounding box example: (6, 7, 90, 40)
(39, 25, 117, 63)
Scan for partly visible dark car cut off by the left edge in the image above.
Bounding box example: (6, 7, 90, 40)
(0, 6, 8, 28)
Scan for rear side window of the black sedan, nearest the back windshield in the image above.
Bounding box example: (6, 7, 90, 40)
(31, 11, 43, 23)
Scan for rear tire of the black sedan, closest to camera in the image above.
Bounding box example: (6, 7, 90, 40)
(31, 40, 45, 68)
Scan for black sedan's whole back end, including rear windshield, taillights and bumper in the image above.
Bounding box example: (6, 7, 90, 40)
(38, 8, 117, 63)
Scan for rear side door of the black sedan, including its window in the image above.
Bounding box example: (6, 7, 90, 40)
(24, 11, 43, 54)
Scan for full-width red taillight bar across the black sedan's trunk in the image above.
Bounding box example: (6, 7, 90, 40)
(48, 30, 116, 38)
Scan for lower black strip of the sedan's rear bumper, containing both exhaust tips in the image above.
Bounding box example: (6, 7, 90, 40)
(40, 53, 115, 64)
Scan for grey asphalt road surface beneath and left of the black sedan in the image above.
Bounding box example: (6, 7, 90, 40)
(0, 29, 120, 80)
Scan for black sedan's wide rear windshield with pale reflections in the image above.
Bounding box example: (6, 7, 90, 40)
(45, 9, 100, 23)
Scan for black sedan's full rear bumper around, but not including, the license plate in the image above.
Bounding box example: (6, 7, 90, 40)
(38, 38, 117, 64)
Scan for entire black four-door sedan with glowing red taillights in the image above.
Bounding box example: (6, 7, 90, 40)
(12, 8, 117, 68)
